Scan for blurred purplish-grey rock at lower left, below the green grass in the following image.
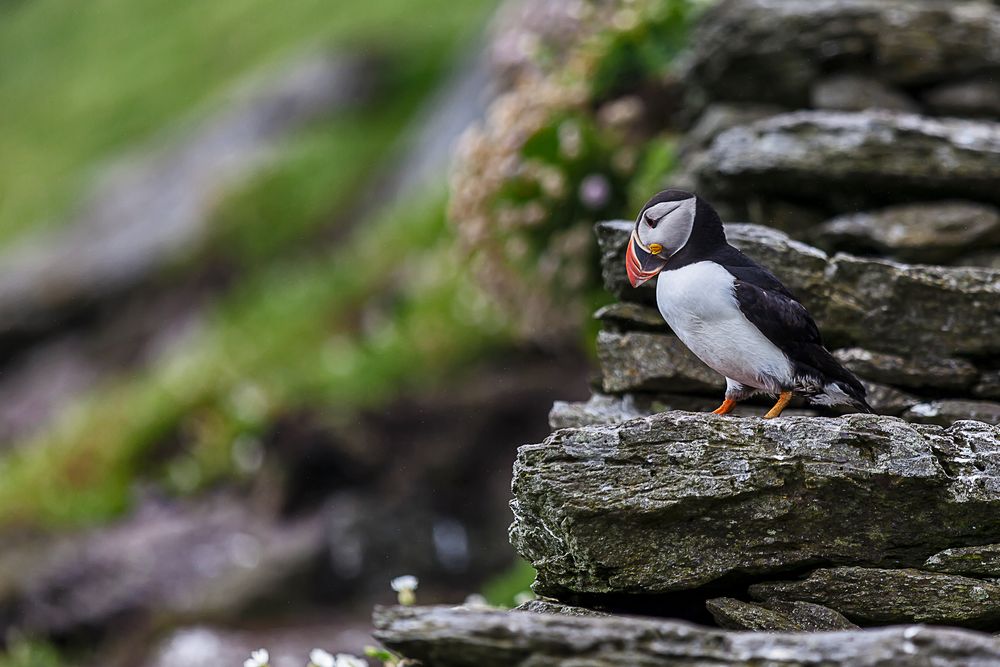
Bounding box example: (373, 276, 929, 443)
(0, 497, 324, 636)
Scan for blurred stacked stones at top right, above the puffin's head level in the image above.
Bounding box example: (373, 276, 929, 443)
(685, 0, 1000, 267)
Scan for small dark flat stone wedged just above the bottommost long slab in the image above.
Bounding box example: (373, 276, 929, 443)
(705, 598, 858, 632)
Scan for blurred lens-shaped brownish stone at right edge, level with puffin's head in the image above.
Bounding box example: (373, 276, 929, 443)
(811, 201, 1000, 263)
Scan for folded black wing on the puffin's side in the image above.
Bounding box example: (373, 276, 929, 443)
(733, 278, 823, 352)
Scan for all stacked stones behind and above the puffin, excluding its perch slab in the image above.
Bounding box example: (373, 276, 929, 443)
(568, 0, 1000, 426)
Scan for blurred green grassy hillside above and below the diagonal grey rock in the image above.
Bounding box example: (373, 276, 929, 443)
(0, 0, 502, 528)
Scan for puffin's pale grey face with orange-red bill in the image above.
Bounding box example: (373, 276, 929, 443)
(625, 190, 698, 287)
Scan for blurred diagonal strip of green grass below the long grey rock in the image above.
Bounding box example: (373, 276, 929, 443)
(0, 199, 508, 527)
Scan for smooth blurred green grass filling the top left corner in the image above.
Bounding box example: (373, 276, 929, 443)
(0, 0, 495, 243)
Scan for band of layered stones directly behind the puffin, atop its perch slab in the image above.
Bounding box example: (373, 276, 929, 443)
(551, 221, 1000, 427)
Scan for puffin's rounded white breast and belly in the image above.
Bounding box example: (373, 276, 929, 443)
(656, 262, 794, 393)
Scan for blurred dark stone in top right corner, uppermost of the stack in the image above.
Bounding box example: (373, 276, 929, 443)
(687, 0, 1000, 107)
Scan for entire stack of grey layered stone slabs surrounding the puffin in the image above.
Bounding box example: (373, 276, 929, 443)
(375, 0, 1000, 667)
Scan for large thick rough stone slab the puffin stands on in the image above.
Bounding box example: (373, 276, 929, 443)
(510, 412, 1000, 596)
